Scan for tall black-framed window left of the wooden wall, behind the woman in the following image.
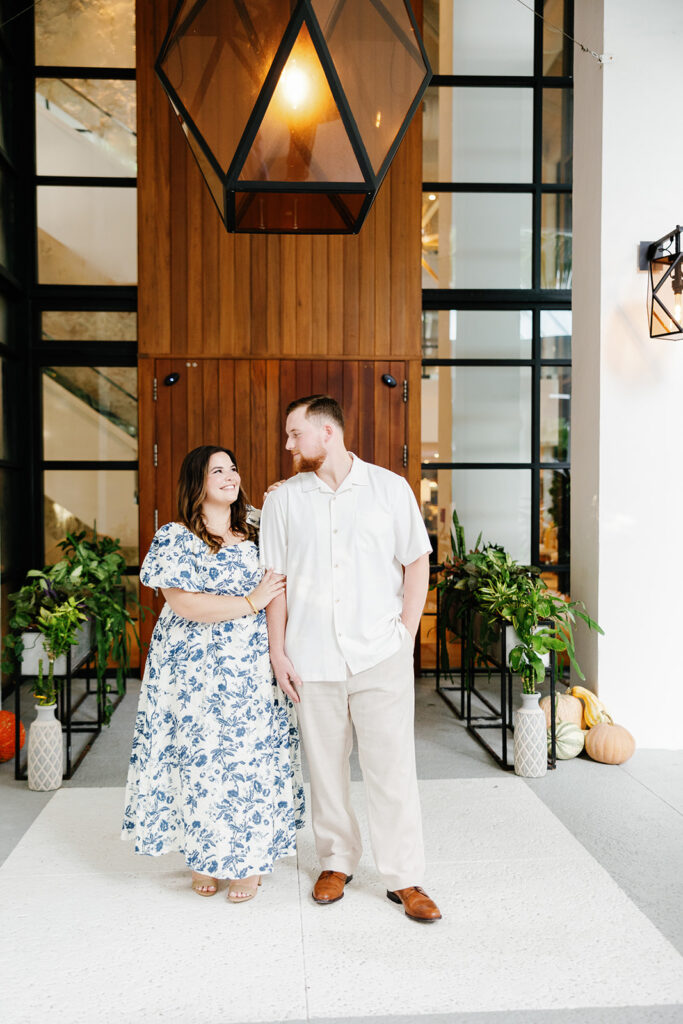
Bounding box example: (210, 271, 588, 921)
(32, 0, 139, 647)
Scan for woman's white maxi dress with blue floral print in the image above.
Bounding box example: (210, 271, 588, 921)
(122, 522, 303, 879)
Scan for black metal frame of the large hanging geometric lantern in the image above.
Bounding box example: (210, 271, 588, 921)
(155, 0, 432, 234)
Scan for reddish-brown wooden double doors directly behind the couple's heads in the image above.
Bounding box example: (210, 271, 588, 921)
(140, 357, 409, 642)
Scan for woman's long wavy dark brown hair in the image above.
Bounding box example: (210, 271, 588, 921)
(178, 444, 258, 554)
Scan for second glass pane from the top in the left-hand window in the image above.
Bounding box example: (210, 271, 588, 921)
(36, 78, 137, 177)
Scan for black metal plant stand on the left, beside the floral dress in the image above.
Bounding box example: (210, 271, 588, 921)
(14, 645, 126, 780)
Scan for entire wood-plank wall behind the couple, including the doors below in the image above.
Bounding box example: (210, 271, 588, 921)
(136, 0, 422, 630)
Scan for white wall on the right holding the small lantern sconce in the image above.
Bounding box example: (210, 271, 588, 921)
(571, 0, 683, 749)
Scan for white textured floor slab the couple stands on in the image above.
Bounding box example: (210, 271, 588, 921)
(0, 775, 683, 1024)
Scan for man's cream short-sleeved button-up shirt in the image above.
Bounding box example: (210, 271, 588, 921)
(261, 456, 431, 682)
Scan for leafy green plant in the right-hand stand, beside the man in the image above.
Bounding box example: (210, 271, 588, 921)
(436, 511, 603, 693)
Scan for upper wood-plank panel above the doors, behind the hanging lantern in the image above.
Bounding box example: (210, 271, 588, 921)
(137, 0, 422, 358)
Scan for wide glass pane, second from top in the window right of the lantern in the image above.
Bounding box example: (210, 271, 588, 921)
(423, 86, 533, 182)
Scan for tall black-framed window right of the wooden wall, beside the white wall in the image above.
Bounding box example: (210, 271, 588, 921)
(421, 0, 572, 591)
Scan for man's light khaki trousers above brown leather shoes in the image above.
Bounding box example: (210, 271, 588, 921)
(297, 632, 425, 890)
